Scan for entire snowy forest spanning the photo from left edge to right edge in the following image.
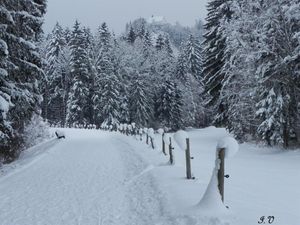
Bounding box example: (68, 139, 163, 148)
(0, 0, 300, 163)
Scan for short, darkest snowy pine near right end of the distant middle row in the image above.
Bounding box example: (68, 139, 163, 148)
(155, 78, 182, 131)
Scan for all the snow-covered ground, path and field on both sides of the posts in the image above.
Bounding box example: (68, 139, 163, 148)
(0, 127, 300, 225)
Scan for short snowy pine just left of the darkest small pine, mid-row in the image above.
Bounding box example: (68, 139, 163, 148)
(130, 76, 153, 127)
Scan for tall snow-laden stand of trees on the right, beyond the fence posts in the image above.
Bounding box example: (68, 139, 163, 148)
(203, 0, 300, 147)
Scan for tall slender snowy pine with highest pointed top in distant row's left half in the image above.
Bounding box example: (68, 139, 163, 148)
(67, 21, 89, 126)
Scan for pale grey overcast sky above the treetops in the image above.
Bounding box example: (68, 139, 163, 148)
(44, 0, 208, 33)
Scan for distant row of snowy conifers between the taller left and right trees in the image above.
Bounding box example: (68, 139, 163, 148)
(41, 21, 205, 130)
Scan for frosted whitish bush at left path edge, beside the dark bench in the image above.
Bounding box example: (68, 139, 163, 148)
(23, 114, 50, 148)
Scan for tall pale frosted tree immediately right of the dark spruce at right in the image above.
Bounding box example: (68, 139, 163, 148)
(220, 0, 262, 141)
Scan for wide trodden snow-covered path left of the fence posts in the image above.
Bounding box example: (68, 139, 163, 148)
(0, 130, 166, 225)
